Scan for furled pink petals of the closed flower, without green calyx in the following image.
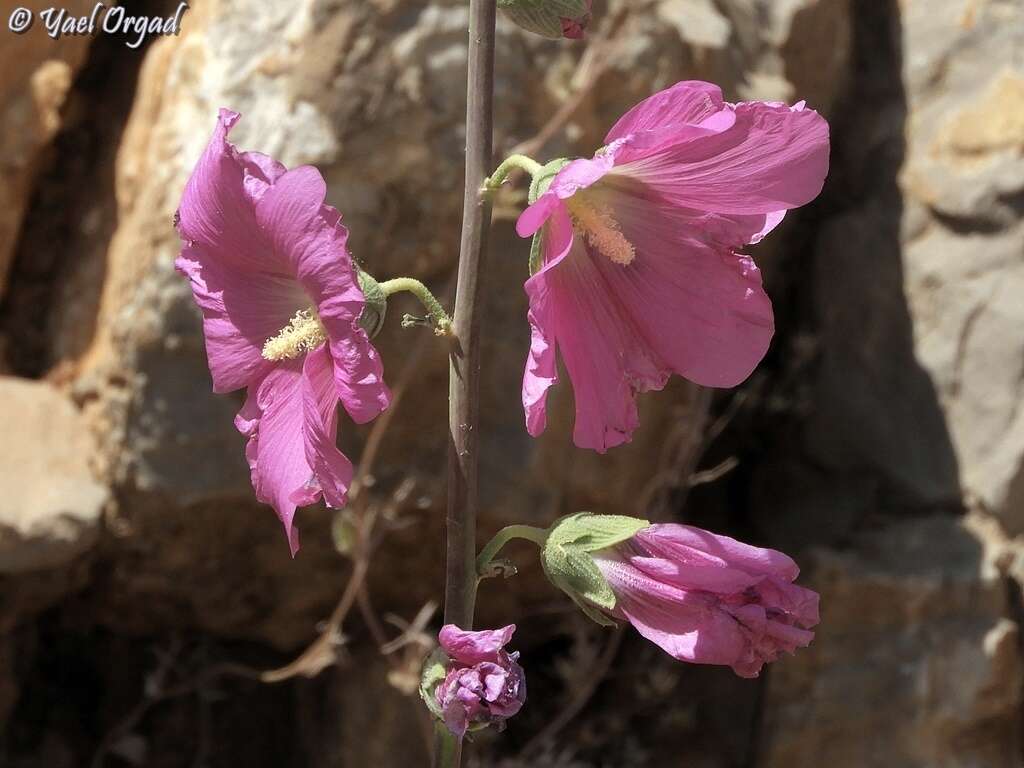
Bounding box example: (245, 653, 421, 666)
(591, 524, 818, 677)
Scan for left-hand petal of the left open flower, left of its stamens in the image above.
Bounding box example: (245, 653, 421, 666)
(174, 242, 309, 392)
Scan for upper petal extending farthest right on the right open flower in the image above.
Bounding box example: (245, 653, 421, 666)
(615, 103, 828, 214)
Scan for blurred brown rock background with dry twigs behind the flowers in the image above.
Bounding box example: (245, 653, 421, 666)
(0, 0, 1024, 768)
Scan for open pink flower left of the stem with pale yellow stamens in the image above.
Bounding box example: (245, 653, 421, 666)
(175, 110, 390, 555)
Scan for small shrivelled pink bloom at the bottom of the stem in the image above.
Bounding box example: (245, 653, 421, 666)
(435, 624, 526, 738)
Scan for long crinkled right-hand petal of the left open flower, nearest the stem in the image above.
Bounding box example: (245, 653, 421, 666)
(256, 166, 391, 423)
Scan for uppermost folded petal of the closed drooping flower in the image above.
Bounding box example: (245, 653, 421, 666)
(634, 523, 800, 582)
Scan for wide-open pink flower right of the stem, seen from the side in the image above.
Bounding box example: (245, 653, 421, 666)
(517, 82, 828, 453)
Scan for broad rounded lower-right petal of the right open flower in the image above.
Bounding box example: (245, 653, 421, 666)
(592, 191, 774, 387)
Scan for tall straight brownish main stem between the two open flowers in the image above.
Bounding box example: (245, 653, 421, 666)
(435, 0, 497, 767)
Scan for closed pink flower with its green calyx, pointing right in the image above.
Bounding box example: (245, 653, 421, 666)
(543, 513, 818, 677)
